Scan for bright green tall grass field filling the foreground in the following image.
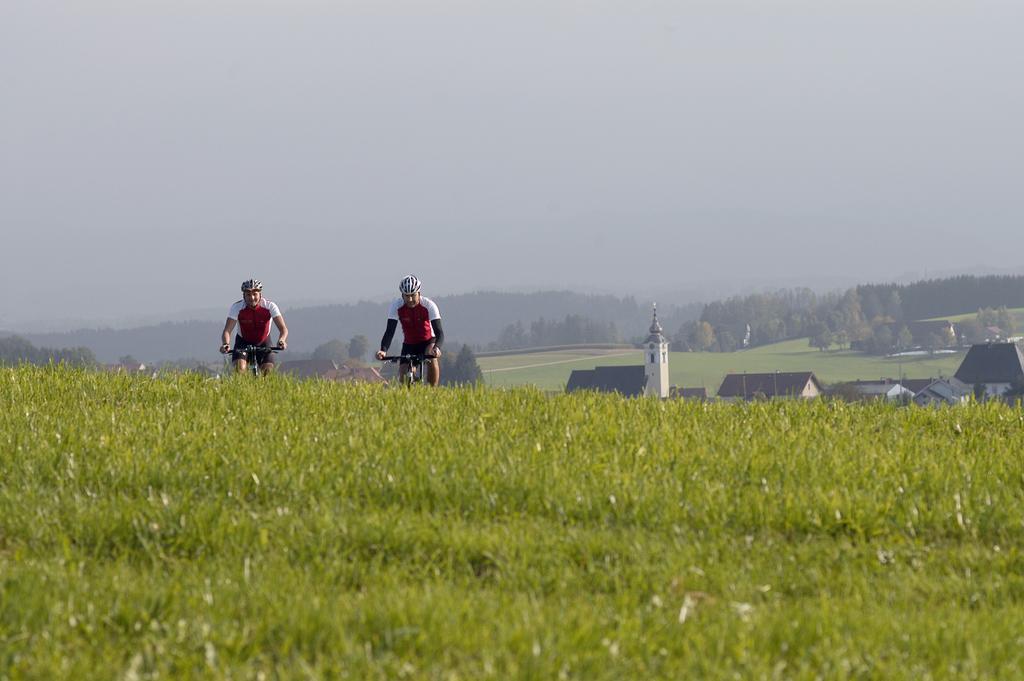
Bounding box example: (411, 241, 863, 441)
(0, 368, 1024, 679)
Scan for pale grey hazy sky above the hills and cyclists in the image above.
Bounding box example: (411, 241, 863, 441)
(0, 0, 1024, 328)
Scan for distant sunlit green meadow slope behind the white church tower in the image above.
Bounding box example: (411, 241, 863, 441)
(479, 339, 964, 393)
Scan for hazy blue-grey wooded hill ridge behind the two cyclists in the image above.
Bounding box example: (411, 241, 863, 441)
(12, 291, 701, 363)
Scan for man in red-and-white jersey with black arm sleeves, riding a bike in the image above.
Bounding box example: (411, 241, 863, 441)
(377, 274, 444, 386)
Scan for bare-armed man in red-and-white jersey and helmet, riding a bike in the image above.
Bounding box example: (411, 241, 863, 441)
(220, 279, 288, 374)
